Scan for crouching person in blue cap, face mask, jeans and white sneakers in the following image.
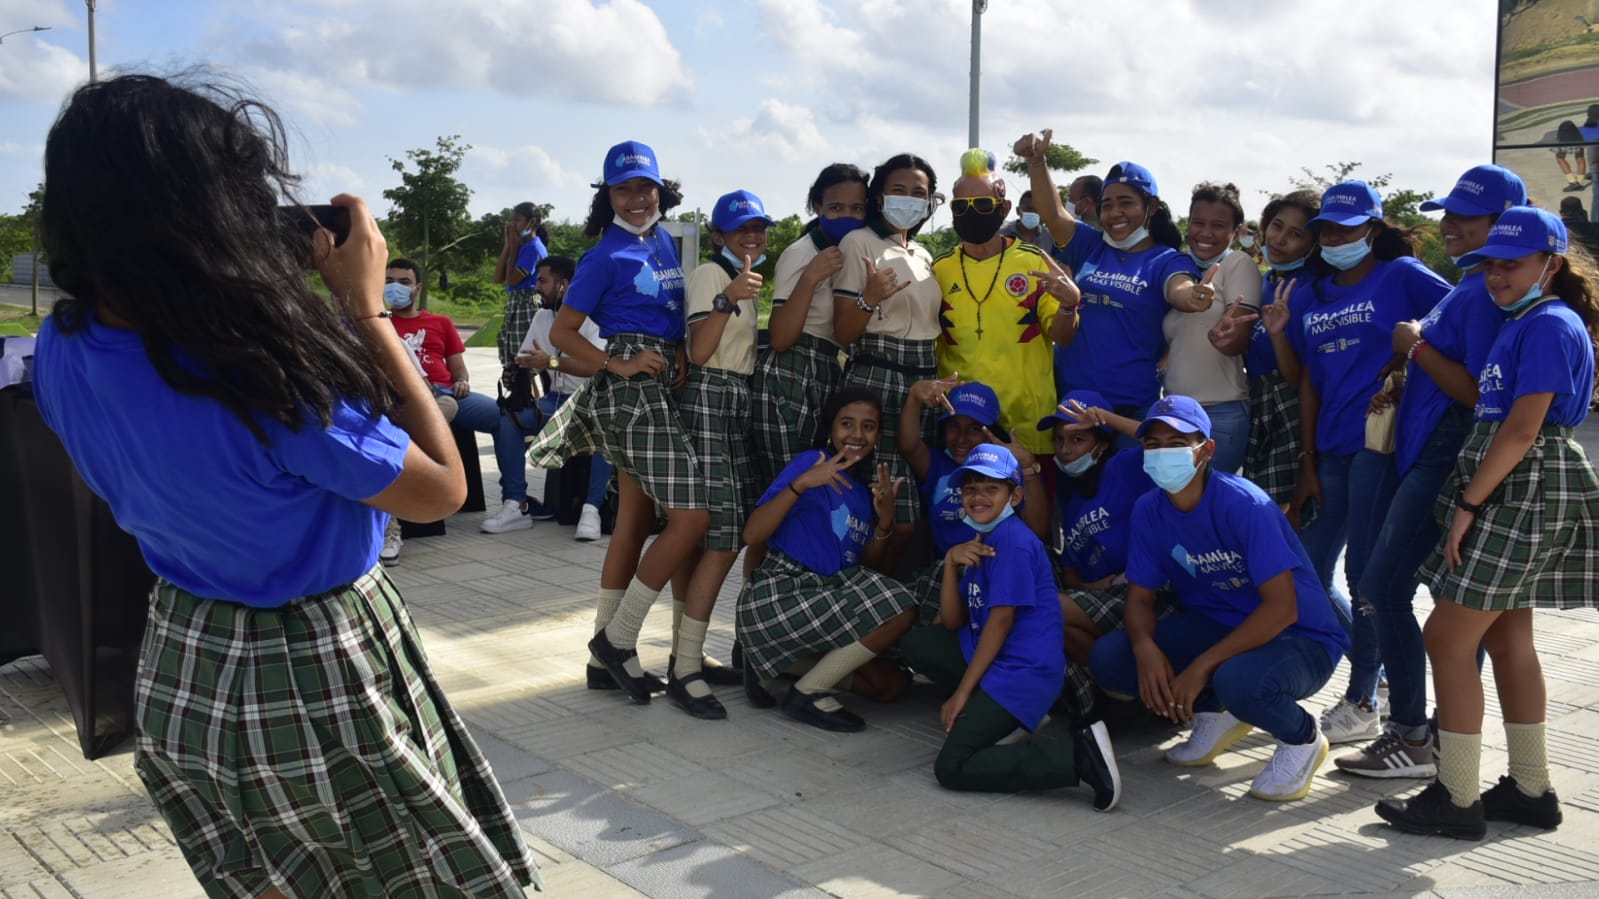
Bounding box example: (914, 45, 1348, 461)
(1089, 397, 1350, 801)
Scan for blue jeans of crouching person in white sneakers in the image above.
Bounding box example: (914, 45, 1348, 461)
(1089, 609, 1337, 745)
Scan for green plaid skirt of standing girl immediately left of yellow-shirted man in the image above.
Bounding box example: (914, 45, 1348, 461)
(843, 334, 939, 525)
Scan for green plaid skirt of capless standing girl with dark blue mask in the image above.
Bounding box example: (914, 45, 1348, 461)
(750, 334, 844, 489)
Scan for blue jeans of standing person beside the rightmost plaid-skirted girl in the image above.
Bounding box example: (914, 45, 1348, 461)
(1358, 406, 1471, 728)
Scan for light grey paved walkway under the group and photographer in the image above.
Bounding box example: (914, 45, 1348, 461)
(0, 343, 1599, 899)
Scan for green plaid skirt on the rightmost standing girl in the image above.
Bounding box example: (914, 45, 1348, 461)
(1418, 421, 1599, 611)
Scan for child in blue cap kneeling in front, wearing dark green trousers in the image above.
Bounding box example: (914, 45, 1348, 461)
(900, 443, 1121, 811)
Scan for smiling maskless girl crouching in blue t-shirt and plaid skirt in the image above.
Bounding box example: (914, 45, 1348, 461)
(737, 387, 916, 731)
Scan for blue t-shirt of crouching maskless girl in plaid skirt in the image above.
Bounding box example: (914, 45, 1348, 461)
(756, 450, 875, 574)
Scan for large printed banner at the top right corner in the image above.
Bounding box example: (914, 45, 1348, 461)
(1493, 0, 1599, 246)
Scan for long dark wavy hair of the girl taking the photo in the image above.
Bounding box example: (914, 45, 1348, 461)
(42, 70, 393, 443)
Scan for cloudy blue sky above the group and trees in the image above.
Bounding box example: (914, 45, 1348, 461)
(0, 0, 1495, 230)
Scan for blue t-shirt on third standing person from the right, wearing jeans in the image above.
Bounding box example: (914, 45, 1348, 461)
(1287, 256, 1449, 456)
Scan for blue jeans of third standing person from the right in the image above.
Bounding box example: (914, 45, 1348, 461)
(1300, 450, 1398, 702)
